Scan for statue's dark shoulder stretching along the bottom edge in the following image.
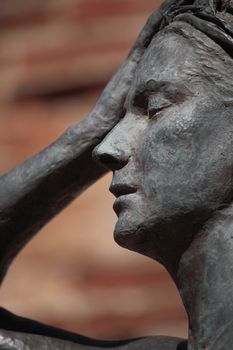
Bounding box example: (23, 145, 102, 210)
(0, 308, 187, 350)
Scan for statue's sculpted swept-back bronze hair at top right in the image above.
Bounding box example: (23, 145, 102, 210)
(152, 0, 233, 103)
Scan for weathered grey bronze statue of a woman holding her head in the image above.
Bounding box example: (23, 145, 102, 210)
(0, 0, 233, 350)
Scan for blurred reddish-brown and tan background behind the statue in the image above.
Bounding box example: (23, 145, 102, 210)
(0, 0, 187, 339)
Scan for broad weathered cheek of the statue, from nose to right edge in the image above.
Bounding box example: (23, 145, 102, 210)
(138, 108, 232, 207)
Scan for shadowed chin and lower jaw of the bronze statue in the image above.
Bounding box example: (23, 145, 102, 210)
(114, 211, 196, 262)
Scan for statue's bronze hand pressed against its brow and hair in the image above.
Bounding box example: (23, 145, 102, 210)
(69, 0, 177, 147)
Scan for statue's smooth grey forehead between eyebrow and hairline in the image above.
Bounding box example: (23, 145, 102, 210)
(133, 32, 199, 88)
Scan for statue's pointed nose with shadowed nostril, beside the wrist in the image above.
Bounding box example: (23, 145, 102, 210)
(93, 125, 130, 171)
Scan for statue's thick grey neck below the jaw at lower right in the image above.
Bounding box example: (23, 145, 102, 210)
(173, 208, 233, 350)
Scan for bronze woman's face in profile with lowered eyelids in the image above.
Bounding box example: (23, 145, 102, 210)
(94, 33, 233, 261)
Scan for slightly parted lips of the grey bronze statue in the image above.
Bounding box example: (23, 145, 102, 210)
(109, 183, 137, 216)
